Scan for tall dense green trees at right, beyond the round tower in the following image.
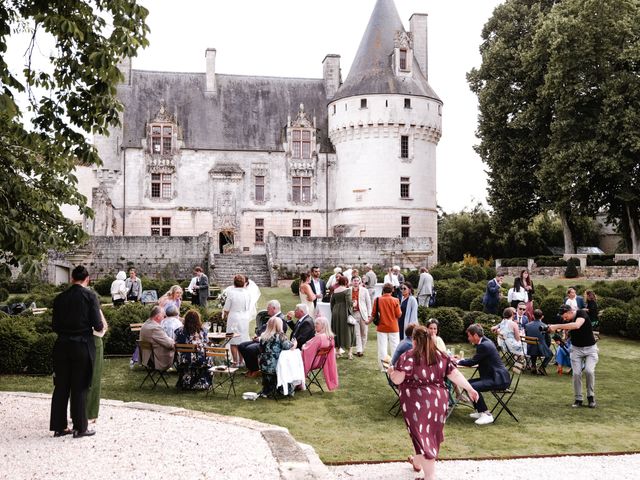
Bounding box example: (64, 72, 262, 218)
(468, 0, 640, 253)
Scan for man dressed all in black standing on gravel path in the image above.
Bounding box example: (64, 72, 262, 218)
(49, 266, 103, 438)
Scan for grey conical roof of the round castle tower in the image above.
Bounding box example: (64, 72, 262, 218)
(333, 0, 440, 100)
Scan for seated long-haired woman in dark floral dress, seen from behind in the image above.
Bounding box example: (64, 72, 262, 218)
(175, 310, 211, 390)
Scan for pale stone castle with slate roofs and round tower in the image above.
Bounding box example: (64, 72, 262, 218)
(69, 0, 442, 260)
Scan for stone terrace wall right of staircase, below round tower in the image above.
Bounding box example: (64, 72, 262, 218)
(267, 233, 435, 278)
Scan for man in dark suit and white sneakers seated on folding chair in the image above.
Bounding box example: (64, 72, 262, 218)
(458, 323, 511, 425)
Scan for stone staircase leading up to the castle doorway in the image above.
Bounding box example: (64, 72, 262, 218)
(211, 253, 271, 288)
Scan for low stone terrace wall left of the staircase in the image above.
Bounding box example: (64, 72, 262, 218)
(67, 235, 211, 279)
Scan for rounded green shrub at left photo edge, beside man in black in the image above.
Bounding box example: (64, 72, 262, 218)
(0, 317, 35, 373)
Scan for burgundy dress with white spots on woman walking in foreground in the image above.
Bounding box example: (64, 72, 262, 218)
(395, 349, 455, 459)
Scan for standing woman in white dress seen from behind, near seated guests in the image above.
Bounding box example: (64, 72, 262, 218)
(222, 275, 251, 366)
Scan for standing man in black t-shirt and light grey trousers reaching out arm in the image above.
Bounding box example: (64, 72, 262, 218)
(549, 303, 598, 408)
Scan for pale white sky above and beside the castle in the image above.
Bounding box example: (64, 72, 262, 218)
(133, 0, 502, 212)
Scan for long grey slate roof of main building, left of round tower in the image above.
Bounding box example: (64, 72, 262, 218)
(118, 70, 333, 152)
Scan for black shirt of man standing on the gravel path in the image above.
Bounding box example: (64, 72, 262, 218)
(53, 284, 103, 336)
